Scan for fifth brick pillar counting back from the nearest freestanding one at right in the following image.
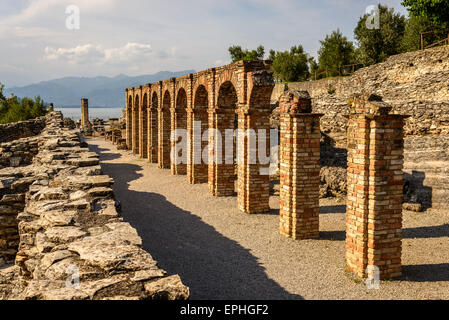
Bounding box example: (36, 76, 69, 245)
(187, 108, 209, 184)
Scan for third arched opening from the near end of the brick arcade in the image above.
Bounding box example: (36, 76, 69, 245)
(171, 88, 187, 175)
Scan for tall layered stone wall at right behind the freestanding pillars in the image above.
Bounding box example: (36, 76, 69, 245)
(271, 46, 449, 209)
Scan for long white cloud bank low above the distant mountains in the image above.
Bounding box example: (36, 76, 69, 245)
(44, 42, 152, 64)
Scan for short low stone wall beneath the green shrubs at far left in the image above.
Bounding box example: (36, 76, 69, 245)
(0, 117, 45, 143)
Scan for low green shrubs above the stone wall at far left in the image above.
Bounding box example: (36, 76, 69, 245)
(0, 84, 47, 123)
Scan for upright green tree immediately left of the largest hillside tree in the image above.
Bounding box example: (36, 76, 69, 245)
(318, 29, 354, 76)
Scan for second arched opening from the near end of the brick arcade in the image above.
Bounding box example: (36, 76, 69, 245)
(187, 85, 209, 184)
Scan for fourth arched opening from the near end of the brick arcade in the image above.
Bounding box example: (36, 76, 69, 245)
(158, 90, 171, 168)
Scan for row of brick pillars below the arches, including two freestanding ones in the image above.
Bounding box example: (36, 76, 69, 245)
(122, 87, 406, 279)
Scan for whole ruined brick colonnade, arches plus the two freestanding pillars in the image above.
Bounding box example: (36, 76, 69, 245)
(126, 61, 406, 279)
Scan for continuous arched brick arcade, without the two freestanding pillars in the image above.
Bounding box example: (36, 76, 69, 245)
(126, 61, 274, 213)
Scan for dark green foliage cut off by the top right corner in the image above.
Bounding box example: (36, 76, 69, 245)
(401, 0, 449, 25)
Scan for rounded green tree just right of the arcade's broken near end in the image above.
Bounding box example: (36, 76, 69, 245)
(270, 45, 310, 82)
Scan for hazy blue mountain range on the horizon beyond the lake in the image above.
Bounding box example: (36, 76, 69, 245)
(4, 70, 195, 108)
